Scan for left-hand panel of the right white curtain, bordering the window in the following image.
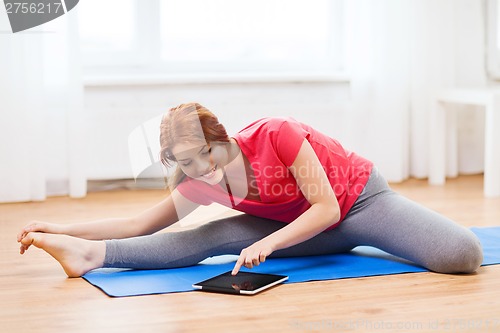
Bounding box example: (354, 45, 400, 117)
(346, 0, 410, 181)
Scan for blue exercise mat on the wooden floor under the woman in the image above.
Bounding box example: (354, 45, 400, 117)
(83, 227, 500, 297)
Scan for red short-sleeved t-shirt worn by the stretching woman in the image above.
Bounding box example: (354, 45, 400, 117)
(177, 118, 373, 229)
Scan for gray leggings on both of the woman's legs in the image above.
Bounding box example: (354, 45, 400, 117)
(104, 168, 483, 273)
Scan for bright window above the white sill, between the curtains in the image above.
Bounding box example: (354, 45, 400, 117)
(78, 0, 344, 80)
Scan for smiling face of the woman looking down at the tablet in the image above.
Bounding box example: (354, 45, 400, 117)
(172, 142, 229, 185)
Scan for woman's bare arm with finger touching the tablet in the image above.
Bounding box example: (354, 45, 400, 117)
(232, 139, 340, 275)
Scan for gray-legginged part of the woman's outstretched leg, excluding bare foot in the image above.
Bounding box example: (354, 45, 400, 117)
(100, 214, 353, 269)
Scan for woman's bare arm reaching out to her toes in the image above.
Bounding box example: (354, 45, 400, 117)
(17, 190, 198, 241)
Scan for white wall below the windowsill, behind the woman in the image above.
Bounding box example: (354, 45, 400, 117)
(80, 82, 350, 179)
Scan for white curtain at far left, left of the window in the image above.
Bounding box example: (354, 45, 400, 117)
(0, 10, 86, 202)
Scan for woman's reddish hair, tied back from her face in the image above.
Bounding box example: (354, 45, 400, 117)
(160, 103, 229, 188)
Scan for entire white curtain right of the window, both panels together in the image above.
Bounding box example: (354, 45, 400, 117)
(346, 0, 470, 181)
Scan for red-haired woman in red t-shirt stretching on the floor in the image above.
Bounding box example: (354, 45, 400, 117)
(17, 103, 483, 277)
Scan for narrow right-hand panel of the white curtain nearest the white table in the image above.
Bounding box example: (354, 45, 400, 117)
(409, 0, 460, 178)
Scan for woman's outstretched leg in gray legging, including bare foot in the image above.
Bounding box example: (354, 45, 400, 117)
(21, 214, 352, 277)
